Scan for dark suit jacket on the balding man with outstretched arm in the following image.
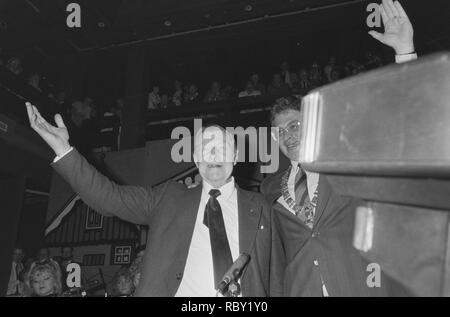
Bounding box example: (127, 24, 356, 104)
(53, 149, 281, 297)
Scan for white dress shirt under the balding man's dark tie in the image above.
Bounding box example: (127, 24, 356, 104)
(175, 178, 239, 297)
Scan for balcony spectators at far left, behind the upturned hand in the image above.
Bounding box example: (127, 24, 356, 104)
(0, 55, 124, 158)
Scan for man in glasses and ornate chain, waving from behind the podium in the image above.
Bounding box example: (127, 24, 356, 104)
(261, 0, 416, 296)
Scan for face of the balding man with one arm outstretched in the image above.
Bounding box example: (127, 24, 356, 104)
(194, 127, 237, 188)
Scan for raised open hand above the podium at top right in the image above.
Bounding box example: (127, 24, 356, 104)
(369, 0, 414, 55)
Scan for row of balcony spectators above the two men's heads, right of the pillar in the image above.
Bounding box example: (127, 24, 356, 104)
(147, 52, 384, 110)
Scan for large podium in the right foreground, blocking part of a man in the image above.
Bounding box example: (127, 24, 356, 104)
(301, 53, 450, 296)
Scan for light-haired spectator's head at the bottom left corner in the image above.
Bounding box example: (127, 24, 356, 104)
(28, 262, 61, 297)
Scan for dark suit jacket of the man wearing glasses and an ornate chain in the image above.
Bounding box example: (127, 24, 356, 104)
(261, 171, 406, 296)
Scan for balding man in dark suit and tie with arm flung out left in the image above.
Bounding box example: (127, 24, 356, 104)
(27, 103, 281, 297)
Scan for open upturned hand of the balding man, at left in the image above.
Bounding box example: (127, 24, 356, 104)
(25, 102, 70, 156)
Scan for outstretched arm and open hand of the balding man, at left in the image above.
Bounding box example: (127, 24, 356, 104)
(26, 103, 166, 224)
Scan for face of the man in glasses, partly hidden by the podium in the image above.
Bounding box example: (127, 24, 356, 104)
(273, 109, 302, 162)
